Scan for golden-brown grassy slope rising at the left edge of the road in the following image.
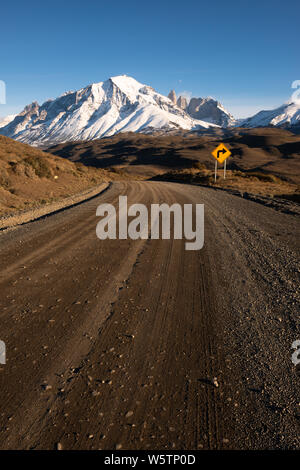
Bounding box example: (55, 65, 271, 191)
(0, 135, 114, 216)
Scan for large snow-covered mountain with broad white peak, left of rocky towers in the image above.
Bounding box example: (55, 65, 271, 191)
(0, 75, 214, 147)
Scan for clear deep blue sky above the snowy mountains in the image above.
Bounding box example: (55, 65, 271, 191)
(0, 0, 300, 117)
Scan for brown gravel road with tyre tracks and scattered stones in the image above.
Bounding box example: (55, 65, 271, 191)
(0, 182, 300, 450)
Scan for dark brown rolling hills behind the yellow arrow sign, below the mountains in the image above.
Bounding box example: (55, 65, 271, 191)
(49, 128, 300, 183)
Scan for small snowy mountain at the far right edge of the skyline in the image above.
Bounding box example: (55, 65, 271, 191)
(241, 103, 300, 127)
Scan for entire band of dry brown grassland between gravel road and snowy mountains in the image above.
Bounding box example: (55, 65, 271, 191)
(0, 129, 300, 216)
